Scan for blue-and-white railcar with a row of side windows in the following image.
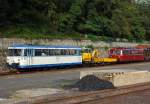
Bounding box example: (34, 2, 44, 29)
(7, 45, 82, 69)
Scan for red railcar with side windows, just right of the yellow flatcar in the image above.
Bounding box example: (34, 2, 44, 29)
(109, 48, 144, 62)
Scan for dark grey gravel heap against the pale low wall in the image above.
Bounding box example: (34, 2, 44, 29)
(74, 75, 115, 91)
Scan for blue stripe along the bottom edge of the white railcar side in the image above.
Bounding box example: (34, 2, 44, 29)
(17, 62, 82, 69)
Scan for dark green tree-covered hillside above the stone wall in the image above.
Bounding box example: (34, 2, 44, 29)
(0, 0, 150, 40)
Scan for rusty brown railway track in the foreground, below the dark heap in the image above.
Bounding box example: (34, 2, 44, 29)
(17, 82, 150, 104)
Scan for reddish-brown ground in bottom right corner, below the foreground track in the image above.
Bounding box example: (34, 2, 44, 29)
(87, 90, 150, 104)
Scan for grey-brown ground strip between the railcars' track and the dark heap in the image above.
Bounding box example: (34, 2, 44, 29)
(0, 62, 150, 98)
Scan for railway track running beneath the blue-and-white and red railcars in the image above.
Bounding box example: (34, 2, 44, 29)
(0, 62, 149, 76)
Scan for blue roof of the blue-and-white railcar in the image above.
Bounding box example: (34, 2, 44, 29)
(8, 44, 81, 49)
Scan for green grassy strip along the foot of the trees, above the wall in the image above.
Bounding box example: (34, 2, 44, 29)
(0, 25, 108, 41)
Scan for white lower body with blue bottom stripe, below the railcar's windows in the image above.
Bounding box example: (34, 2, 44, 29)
(7, 56, 82, 68)
